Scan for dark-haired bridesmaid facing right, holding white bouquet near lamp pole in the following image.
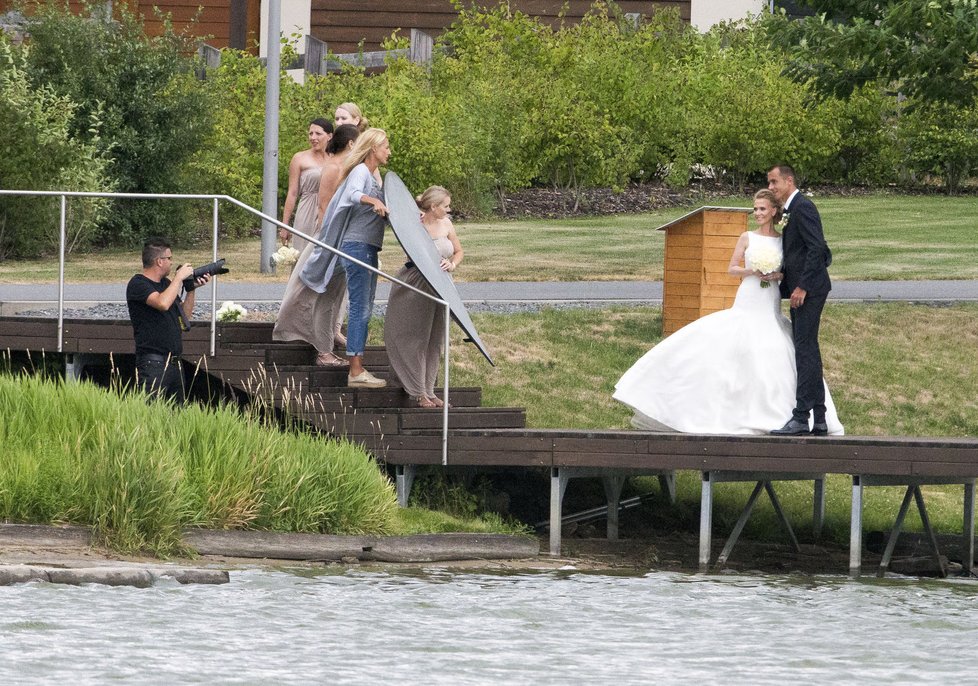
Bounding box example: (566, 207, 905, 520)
(278, 119, 333, 252)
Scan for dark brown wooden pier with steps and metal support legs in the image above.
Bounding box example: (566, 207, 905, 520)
(0, 317, 978, 575)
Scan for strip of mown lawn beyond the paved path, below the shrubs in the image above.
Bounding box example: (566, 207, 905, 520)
(0, 193, 978, 283)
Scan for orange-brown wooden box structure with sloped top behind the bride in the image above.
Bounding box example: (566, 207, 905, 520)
(658, 207, 751, 336)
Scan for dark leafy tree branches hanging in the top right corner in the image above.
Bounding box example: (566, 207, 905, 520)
(768, 0, 978, 107)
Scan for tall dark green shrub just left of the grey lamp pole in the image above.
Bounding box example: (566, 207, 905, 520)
(17, 0, 209, 244)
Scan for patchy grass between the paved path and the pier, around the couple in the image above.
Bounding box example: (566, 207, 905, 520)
(424, 303, 978, 543)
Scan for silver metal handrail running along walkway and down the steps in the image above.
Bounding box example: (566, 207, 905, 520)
(0, 189, 452, 465)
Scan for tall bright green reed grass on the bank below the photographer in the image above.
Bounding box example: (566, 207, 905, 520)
(0, 374, 397, 555)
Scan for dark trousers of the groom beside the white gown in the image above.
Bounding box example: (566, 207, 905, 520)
(791, 295, 828, 422)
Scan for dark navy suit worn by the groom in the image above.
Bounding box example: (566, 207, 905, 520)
(780, 193, 832, 422)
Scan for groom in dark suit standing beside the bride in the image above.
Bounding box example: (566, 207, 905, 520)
(767, 164, 832, 436)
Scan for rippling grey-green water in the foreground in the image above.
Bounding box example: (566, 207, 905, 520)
(0, 569, 978, 685)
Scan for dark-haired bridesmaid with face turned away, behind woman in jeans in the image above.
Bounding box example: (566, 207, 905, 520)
(272, 124, 360, 367)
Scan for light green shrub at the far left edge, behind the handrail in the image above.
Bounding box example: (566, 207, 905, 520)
(0, 34, 112, 260)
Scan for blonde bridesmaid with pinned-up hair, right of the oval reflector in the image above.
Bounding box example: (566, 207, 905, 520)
(384, 186, 464, 408)
